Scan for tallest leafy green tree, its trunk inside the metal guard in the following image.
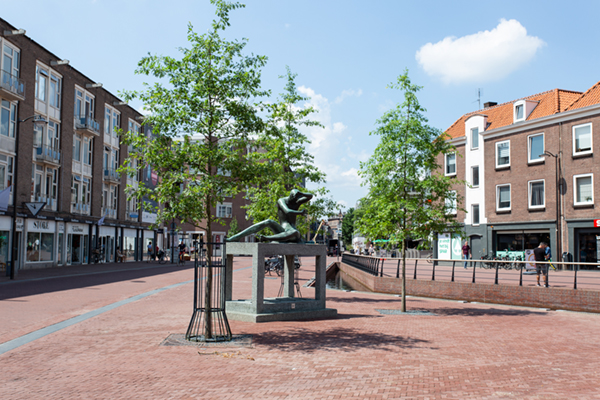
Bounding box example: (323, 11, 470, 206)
(121, 0, 268, 339)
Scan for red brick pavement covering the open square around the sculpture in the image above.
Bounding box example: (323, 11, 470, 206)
(0, 259, 600, 399)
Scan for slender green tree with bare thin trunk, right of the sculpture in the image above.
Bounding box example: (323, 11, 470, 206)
(355, 71, 462, 312)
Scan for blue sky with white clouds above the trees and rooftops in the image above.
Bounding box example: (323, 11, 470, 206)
(0, 0, 600, 206)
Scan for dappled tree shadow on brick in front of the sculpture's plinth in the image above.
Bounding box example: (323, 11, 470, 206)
(253, 328, 429, 353)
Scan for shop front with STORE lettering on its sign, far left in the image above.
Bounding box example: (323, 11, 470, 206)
(25, 218, 56, 268)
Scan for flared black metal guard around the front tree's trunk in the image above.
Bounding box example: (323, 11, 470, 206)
(185, 241, 231, 342)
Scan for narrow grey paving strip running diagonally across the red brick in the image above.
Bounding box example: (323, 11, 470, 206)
(0, 266, 252, 355)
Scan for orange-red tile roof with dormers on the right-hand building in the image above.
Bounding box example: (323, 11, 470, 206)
(446, 82, 600, 139)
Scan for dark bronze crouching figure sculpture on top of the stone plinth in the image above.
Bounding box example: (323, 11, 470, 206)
(227, 189, 313, 243)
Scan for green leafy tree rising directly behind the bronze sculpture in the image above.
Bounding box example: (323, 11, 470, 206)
(245, 67, 339, 233)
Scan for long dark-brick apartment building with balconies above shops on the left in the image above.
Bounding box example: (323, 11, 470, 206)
(0, 19, 161, 269)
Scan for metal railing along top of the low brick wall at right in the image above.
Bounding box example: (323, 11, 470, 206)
(342, 253, 600, 290)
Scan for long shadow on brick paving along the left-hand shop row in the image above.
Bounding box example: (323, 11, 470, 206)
(0, 263, 194, 300)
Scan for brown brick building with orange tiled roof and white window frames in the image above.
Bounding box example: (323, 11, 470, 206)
(439, 82, 600, 268)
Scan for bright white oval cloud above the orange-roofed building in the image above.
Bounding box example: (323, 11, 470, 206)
(416, 19, 546, 84)
